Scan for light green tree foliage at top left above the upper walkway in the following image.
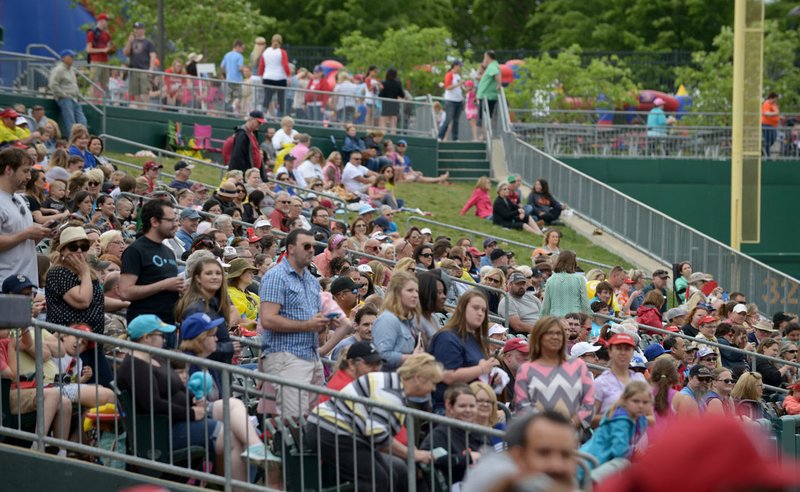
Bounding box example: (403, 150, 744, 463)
(75, 0, 276, 67)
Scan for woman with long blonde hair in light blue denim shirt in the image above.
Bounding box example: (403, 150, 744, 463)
(372, 271, 427, 371)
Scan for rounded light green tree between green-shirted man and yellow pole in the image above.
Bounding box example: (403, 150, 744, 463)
(506, 45, 637, 119)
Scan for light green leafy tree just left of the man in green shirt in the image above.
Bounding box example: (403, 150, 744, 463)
(335, 25, 458, 94)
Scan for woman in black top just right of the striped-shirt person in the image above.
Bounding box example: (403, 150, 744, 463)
(420, 383, 483, 485)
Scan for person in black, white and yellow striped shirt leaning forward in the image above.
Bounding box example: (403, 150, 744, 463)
(305, 353, 444, 491)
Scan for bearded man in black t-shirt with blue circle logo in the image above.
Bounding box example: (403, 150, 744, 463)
(119, 200, 184, 348)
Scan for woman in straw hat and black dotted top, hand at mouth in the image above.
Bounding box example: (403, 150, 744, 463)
(45, 227, 112, 386)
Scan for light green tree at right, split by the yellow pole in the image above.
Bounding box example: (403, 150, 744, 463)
(678, 21, 800, 117)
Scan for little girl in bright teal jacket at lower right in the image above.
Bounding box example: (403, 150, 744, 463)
(581, 381, 653, 472)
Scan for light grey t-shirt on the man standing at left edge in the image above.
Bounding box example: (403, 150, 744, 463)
(0, 191, 39, 286)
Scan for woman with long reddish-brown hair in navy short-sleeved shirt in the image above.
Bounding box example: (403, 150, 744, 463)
(428, 290, 500, 413)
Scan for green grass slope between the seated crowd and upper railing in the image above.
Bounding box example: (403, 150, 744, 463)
(106, 152, 632, 271)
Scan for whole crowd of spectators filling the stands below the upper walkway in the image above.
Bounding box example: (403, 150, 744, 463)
(0, 84, 800, 488)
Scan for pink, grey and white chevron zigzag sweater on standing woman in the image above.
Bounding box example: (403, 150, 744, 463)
(514, 359, 594, 425)
